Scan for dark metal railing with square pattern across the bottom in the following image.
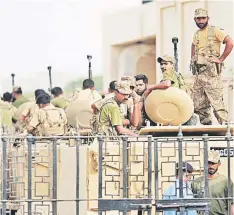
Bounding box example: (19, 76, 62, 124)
(0, 130, 234, 215)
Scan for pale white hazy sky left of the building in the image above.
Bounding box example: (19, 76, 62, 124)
(0, 0, 141, 91)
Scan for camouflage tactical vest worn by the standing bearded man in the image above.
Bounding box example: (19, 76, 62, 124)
(195, 26, 219, 64)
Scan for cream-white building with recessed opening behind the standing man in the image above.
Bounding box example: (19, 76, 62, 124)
(103, 0, 234, 121)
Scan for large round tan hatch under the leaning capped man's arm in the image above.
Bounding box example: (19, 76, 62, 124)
(145, 87, 194, 126)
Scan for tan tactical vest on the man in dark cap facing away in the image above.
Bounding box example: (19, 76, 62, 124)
(37, 108, 67, 136)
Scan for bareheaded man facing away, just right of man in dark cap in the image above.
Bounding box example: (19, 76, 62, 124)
(51, 87, 69, 110)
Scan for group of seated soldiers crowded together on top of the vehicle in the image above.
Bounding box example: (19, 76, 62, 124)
(0, 55, 199, 136)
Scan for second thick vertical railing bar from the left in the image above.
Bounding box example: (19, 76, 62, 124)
(27, 135, 34, 215)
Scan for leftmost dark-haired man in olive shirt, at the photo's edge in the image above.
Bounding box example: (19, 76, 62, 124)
(0, 92, 17, 127)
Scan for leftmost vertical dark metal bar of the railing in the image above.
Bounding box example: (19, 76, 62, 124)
(2, 138, 7, 215)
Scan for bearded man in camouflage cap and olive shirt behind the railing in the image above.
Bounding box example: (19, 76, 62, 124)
(192, 150, 234, 215)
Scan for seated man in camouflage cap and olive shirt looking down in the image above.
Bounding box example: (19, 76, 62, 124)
(98, 81, 137, 137)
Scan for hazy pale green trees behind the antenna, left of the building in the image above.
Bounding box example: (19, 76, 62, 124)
(64, 76, 103, 92)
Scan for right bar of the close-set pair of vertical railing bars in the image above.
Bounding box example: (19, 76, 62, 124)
(154, 138, 159, 214)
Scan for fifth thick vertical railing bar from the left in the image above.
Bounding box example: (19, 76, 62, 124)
(98, 136, 103, 215)
